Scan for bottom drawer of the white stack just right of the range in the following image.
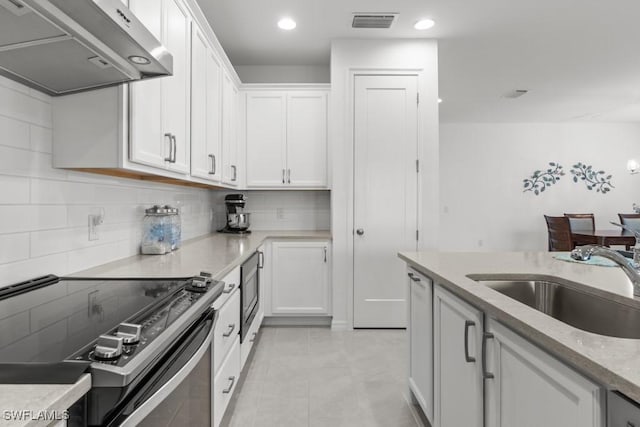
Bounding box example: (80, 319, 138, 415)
(213, 335, 240, 427)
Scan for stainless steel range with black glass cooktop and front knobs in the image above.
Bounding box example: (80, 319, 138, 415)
(0, 275, 224, 426)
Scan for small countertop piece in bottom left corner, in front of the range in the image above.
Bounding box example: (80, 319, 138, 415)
(0, 374, 91, 427)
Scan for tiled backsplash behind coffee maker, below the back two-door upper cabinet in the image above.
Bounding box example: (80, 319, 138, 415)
(212, 190, 331, 231)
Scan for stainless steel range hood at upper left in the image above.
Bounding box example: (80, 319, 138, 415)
(0, 0, 173, 96)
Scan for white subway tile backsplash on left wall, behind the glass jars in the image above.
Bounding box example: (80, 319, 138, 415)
(0, 78, 211, 286)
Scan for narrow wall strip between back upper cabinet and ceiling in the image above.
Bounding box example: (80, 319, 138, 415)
(235, 65, 330, 83)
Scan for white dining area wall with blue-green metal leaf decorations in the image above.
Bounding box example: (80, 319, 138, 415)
(439, 123, 640, 251)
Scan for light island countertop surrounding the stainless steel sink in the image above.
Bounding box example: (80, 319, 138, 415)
(399, 252, 640, 402)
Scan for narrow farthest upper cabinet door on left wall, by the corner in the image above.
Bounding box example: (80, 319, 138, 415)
(222, 72, 238, 185)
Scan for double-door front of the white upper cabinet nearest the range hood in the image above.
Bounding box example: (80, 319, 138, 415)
(129, 0, 191, 174)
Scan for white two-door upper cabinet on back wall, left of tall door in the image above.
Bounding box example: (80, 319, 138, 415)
(246, 90, 328, 188)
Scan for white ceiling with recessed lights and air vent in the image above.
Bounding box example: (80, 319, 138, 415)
(198, 0, 640, 122)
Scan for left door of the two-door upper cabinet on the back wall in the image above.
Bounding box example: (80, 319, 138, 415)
(246, 92, 287, 188)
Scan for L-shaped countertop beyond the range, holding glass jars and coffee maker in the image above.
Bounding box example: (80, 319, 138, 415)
(72, 231, 331, 279)
